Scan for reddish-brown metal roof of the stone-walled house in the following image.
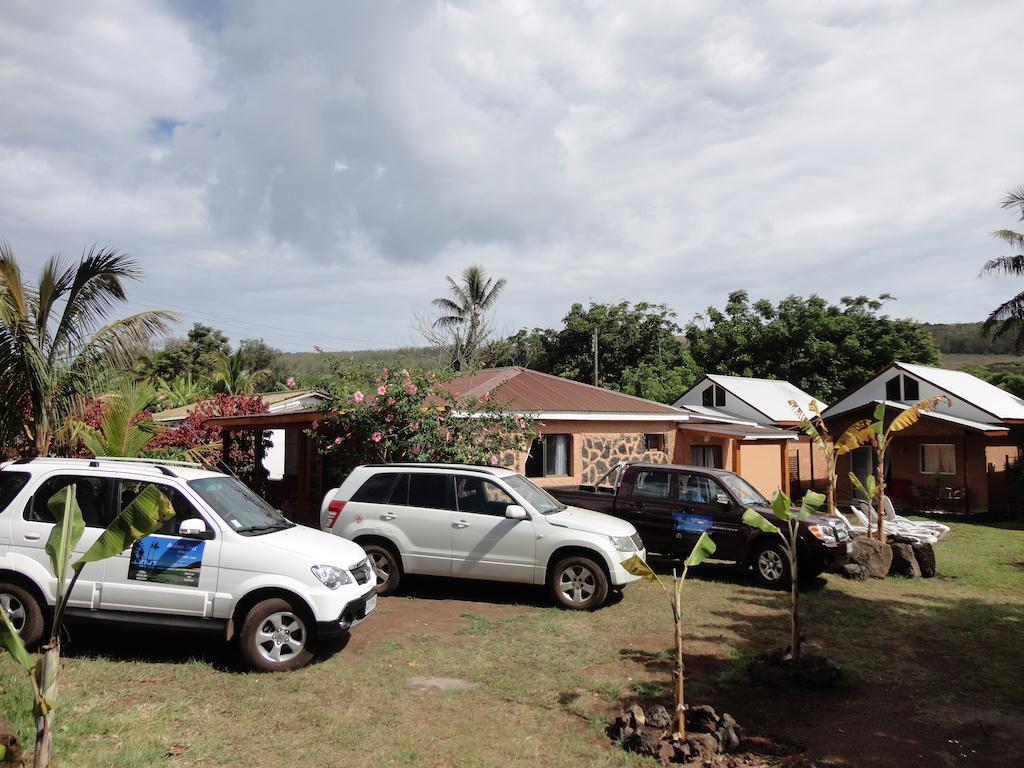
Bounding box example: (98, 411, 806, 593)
(444, 366, 689, 421)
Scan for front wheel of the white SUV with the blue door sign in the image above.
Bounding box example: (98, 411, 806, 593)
(239, 597, 313, 672)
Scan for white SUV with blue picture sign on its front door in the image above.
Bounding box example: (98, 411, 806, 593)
(0, 459, 377, 671)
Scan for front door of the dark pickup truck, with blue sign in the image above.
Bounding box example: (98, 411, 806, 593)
(675, 472, 748, 560)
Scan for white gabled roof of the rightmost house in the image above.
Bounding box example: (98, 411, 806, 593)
(826, 362, 1024, 422)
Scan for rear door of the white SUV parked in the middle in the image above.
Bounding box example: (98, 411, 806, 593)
(387, 472, 456, 575)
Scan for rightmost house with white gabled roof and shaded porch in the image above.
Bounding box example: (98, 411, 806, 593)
(824, 362, 1024, 512)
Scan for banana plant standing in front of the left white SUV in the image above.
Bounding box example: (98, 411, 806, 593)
(0, 485, 174, 768)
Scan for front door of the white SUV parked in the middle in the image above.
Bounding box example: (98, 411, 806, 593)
(452, 475, 537, 584)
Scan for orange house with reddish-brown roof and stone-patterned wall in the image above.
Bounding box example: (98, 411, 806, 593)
(446, 367, 796, 496)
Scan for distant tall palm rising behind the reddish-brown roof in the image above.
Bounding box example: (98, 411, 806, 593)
(433, 264, 507, 371)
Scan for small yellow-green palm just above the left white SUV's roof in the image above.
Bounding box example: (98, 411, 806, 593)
(70, 381, 160, 457)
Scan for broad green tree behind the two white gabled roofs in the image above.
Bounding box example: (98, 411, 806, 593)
(686, 291, 939, 402)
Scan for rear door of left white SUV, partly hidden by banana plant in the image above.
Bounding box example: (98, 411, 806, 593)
(11, 473, 114, 608)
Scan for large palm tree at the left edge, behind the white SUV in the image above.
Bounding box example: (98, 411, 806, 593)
(0, 242, 175, 456)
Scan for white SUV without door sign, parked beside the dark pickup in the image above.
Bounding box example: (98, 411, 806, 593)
(321, 464, 645, 609)
